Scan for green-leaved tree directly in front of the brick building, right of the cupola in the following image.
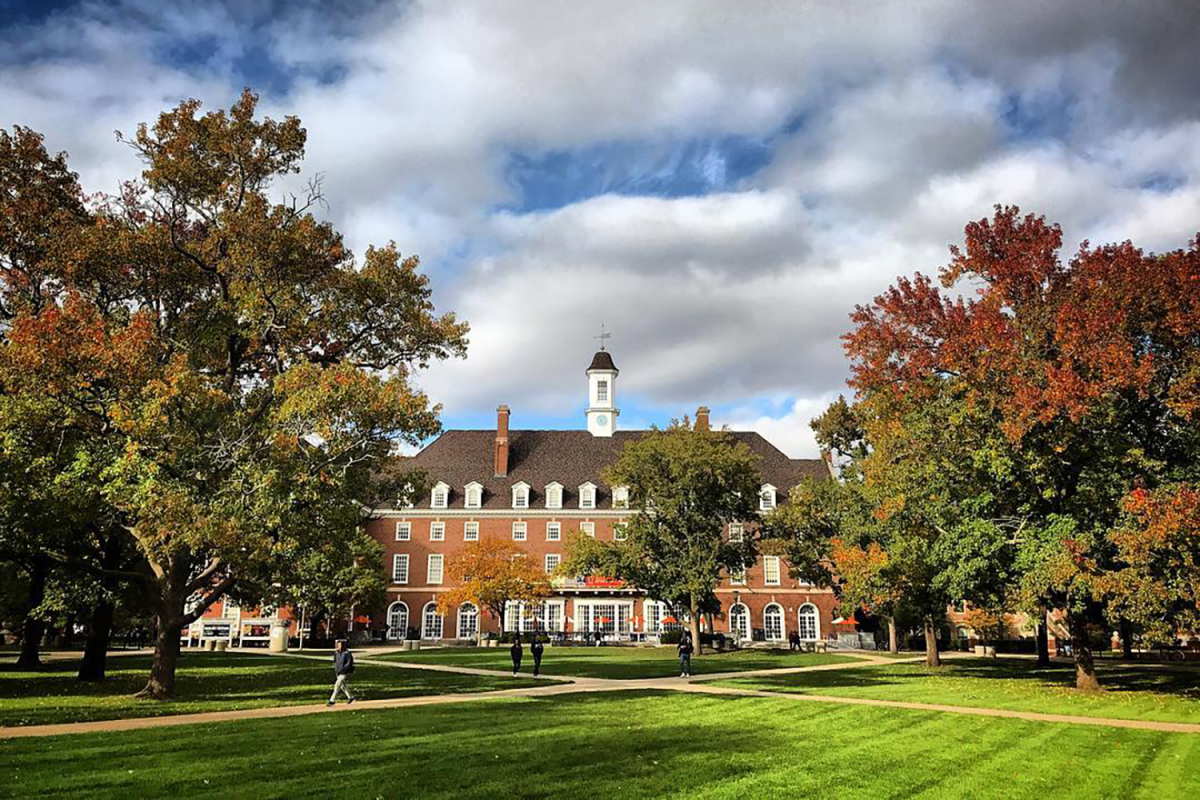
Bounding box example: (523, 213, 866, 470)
(563, 419, 762, 652)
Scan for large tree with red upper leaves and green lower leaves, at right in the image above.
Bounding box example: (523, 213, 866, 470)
(845, 206, 1200, 688)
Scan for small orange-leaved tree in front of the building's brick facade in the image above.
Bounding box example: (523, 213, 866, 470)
(438, 539, 550, 637)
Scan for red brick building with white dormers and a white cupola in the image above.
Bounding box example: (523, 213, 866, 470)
(368, 347, 836, 642)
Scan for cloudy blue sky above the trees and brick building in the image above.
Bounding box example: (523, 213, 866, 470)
(0, 0, 1200, 457)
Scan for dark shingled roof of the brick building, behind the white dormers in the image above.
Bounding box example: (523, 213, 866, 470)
(406, 431, 829, 509)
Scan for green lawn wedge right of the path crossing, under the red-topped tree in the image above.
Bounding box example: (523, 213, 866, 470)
(718, 658, 1200, 723)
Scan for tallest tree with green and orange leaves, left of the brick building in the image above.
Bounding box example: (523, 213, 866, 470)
(8, 91, 467, 698)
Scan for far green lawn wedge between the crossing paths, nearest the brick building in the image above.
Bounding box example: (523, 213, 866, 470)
(382, 645, 854, 679)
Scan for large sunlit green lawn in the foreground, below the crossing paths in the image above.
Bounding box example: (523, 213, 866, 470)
(0, 692, 1200, 800)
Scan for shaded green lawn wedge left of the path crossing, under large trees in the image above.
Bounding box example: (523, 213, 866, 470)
(0, 654, 549, 726)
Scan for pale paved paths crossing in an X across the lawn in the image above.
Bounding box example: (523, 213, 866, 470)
(0, 650, 1200, 739)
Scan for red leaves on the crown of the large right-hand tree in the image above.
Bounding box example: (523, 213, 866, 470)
(844, 206, 1200, 440)
